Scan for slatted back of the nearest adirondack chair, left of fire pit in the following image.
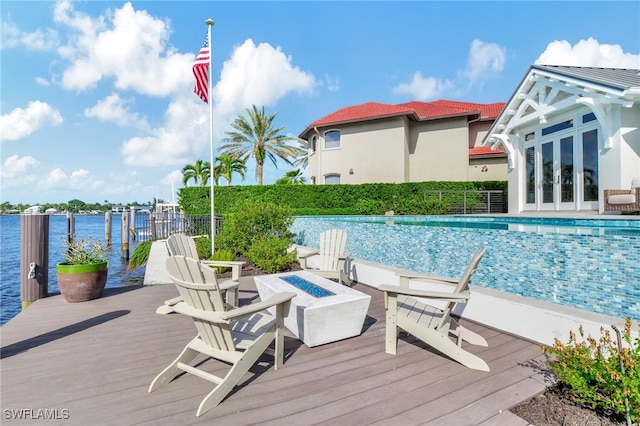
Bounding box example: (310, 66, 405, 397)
(167, 256, 236, 351)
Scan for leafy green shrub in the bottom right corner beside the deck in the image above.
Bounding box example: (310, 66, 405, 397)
(543, 318, 640, 421)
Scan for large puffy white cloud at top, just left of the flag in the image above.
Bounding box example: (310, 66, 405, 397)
(54, 1, 195, 96)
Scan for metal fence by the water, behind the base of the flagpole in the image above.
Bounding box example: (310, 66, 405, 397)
(132, 211, 222, 242)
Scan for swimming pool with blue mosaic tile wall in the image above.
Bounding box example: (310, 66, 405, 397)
(291, 216, 640, 321)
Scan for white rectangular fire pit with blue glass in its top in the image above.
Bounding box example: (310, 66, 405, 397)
(254, 271, 371, 347)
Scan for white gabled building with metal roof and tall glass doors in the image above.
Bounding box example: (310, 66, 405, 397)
(482, 65, 640, 213)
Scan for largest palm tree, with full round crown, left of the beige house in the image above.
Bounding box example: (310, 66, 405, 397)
(220, 105, 303, 185)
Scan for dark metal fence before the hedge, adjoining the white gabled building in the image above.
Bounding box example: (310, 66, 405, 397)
(424, 190, 508, 214)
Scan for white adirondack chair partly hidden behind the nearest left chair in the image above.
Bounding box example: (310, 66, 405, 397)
(162, 234, 245, 306)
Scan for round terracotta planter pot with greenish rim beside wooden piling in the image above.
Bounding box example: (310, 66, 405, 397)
(56, 262, 108, 303)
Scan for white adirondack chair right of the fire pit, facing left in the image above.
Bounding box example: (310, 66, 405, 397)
(379, 247, 489, 371)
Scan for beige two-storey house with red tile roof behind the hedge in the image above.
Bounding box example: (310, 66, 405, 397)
(299, 100, 507, 185)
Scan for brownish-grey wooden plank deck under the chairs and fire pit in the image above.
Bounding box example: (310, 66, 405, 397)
(0, 278, 546, 426)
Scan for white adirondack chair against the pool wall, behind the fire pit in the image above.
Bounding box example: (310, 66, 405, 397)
(298, 229, 351, 284)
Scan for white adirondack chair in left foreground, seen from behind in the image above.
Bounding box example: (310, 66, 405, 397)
(149, 256, 295, 416)
